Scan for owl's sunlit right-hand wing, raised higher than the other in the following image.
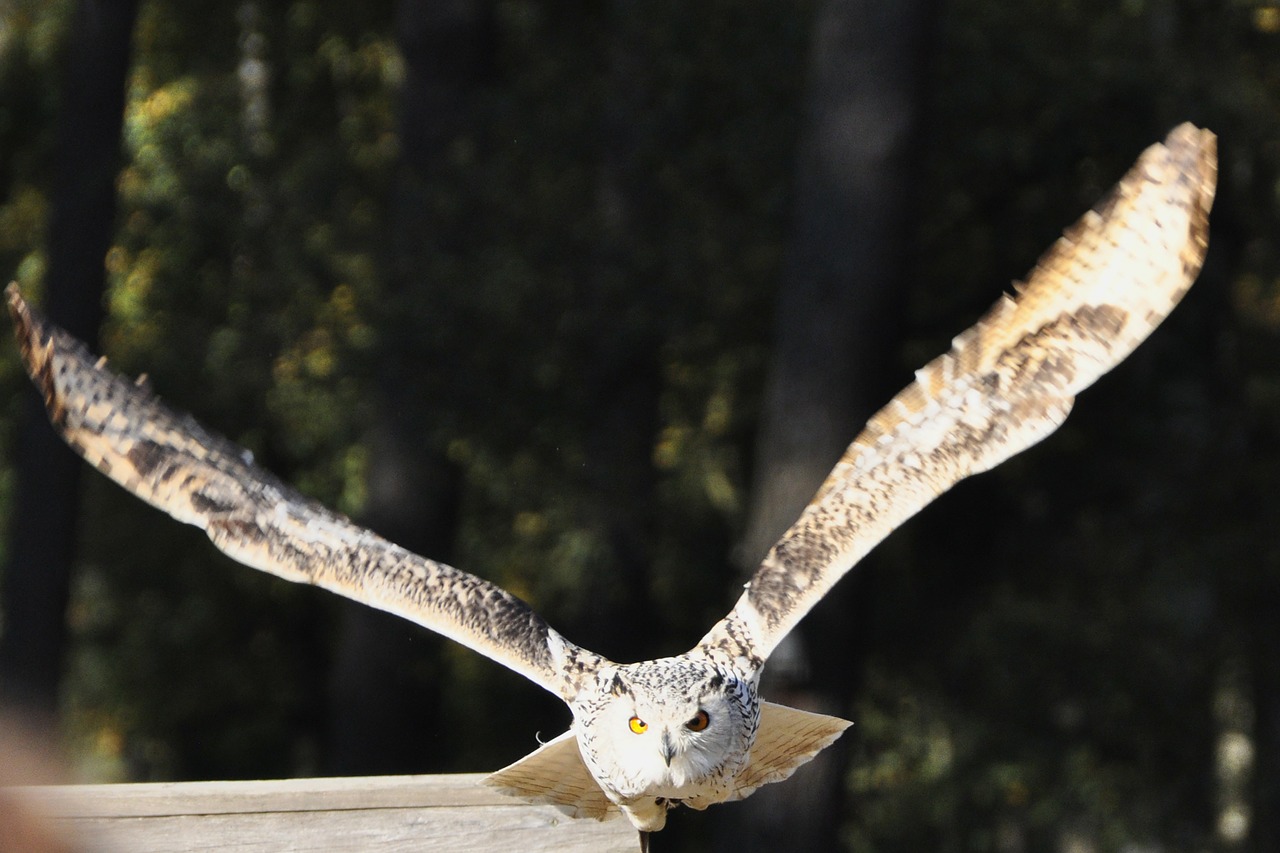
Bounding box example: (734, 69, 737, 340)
(698, 124, 1217, 666)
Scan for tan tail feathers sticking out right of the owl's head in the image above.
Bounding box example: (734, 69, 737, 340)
(721, 702, 854, 808)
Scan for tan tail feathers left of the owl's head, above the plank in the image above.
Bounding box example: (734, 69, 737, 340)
(481, 731, 621, 821)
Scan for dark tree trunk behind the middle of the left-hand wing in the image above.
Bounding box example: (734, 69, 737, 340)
(325, 0, 493, 775)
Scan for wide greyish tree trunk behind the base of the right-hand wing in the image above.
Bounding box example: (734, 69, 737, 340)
(721, 0, 929, 850)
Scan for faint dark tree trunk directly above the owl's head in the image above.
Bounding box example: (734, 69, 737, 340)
(573, 0, 662, 660)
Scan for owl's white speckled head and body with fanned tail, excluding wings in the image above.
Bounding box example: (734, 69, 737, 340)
(485, 656, 849, 831)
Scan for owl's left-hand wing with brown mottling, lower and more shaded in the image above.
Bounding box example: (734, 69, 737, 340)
(6, 284, 602, 701)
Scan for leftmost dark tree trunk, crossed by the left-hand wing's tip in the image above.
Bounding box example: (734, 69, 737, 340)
(0, 0, 137, 721)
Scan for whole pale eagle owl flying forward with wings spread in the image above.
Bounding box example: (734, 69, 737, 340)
(8, 124, 1217, 840)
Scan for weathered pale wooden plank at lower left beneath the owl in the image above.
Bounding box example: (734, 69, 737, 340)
(15, 774, 639, 853)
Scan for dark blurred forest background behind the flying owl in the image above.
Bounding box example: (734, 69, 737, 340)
(0, 0, 1280, 853)
